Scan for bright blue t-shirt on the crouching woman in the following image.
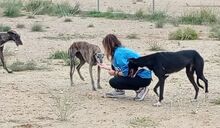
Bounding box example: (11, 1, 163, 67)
(112, 46, 152, 78)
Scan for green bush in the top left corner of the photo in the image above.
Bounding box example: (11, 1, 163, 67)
(1, 0, 23, 17)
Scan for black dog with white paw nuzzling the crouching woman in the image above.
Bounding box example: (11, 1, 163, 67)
(128, 50, 208, 105)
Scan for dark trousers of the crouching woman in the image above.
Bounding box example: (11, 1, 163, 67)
(109, 76, 151, 90)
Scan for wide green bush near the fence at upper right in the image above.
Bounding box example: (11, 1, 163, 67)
(179, 9, 217, 25)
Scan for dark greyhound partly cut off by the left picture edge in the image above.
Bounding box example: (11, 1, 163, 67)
(0, 30, 22, 73)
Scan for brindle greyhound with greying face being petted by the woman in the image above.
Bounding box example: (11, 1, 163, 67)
(68, 42, 104, 91)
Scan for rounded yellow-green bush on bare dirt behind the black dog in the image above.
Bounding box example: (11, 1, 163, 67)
(169, 27, 198, 40)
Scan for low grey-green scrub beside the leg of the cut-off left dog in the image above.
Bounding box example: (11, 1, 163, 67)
(9, 60, 46, 72)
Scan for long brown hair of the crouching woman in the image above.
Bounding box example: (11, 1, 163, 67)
(102, 34, 122, 60)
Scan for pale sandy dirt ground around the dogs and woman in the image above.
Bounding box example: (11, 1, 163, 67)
(0, 0, 220, 128)
